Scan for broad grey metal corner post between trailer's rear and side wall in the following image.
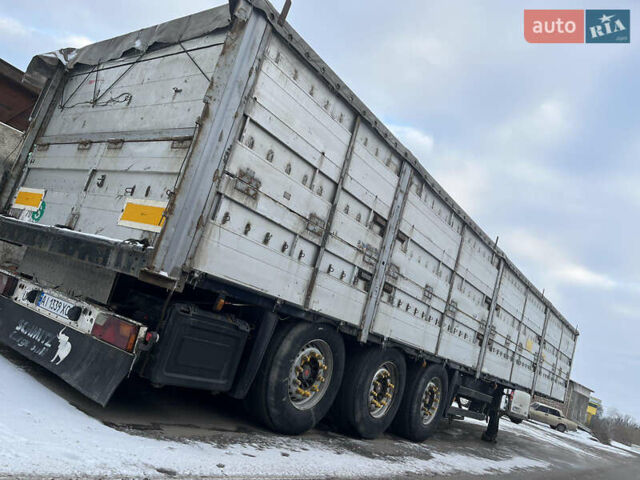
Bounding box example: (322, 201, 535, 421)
(151, 0, 271, 284)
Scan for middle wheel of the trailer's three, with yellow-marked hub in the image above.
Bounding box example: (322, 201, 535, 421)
(332, 348, 407, 439)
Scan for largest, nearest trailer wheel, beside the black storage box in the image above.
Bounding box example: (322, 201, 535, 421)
(245, 322, 345, 435)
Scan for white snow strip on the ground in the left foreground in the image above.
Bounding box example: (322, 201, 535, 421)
(0, 356, 549, 478)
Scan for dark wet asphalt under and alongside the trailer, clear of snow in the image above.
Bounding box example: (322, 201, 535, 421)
(0, 347, 640, 480)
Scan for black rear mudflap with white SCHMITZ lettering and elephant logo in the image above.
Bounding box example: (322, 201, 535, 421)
(0, 297, 135, 406)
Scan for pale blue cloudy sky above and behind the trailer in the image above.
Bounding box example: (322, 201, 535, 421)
(0, 0, 640, 419)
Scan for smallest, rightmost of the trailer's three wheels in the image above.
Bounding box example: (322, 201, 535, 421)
(393, 364, 449, 442)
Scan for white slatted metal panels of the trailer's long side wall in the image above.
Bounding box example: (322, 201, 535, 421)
(194, 28, 573, 398)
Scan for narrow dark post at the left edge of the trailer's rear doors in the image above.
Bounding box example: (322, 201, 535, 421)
(0, 65, 64, 211)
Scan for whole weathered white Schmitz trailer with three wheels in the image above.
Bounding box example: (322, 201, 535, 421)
(0, 0, 578, 439)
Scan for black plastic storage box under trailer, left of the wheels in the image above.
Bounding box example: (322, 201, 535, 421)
(143, 304, 249, 392)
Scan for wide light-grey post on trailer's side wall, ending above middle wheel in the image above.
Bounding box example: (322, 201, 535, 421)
(358, 161, 411, 343)
